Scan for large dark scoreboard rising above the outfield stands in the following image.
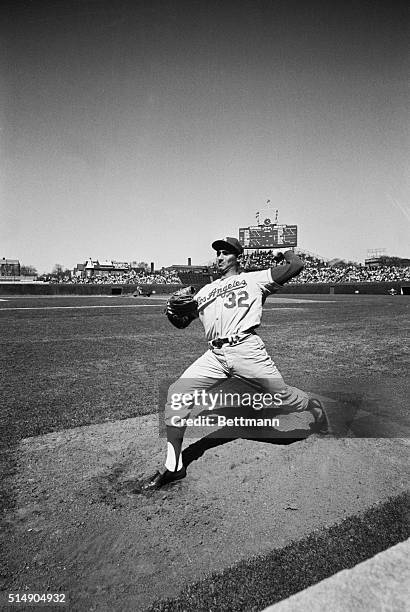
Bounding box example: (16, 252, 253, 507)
(239, 222, 298, 249)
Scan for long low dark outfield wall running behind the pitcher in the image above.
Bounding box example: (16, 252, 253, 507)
(0, 281, 409, 296)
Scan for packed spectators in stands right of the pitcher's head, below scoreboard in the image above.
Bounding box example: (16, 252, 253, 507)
(242, 251, 410, 283)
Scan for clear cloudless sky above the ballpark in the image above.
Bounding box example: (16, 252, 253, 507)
(0, 0, 410, 273)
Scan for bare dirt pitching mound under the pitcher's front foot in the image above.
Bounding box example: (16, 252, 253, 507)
(1, 408, 408, 611)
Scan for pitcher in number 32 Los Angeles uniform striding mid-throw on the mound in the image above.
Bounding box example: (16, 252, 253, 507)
(143, 237, 327, 490)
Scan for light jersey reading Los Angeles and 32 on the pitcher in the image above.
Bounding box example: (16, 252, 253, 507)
(196, 269, 281, 340)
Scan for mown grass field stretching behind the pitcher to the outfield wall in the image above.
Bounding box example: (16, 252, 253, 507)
(0, 295, 409, 610)
